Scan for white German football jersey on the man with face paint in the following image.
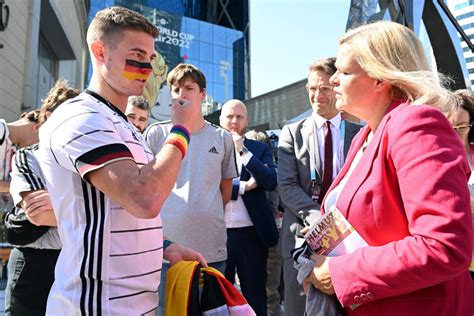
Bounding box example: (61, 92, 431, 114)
(39, 90, 163, 315)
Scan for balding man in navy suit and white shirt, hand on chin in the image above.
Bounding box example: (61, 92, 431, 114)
(220, 100, 278, 315)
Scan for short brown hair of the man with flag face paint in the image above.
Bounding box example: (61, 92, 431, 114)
(87, 6, 159, 48)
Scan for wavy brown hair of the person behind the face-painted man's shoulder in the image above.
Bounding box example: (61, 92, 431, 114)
(39, 79, 79, 123)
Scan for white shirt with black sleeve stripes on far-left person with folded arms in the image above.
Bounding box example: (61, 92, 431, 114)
(10, 144, 61, 249)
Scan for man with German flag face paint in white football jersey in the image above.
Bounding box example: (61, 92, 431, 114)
(38, 7, 206, 315)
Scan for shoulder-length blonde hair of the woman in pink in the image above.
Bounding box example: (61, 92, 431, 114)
(339, 21, 457, 111)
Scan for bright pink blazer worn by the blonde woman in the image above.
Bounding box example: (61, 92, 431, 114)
(323, 101, 474, 316)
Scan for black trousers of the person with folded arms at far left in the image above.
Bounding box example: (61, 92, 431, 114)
(5, 248, 59, 316)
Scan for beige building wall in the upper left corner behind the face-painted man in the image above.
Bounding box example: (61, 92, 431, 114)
(0, 0, 87, 122)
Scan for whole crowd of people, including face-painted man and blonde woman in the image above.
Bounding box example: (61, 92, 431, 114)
(0, 7, 474, 316)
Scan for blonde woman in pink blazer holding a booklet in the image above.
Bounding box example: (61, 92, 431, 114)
(307, 22, 474, 316)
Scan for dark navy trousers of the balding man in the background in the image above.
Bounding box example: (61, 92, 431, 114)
(225, 226, 268, 316)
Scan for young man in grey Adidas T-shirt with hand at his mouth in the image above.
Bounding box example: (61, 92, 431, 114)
(144, 64, 237, 315)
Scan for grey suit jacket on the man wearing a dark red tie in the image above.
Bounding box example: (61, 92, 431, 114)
(278, 117, 361, 258)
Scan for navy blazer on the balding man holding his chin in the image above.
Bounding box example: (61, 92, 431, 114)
(232, 138, 278, 248)
